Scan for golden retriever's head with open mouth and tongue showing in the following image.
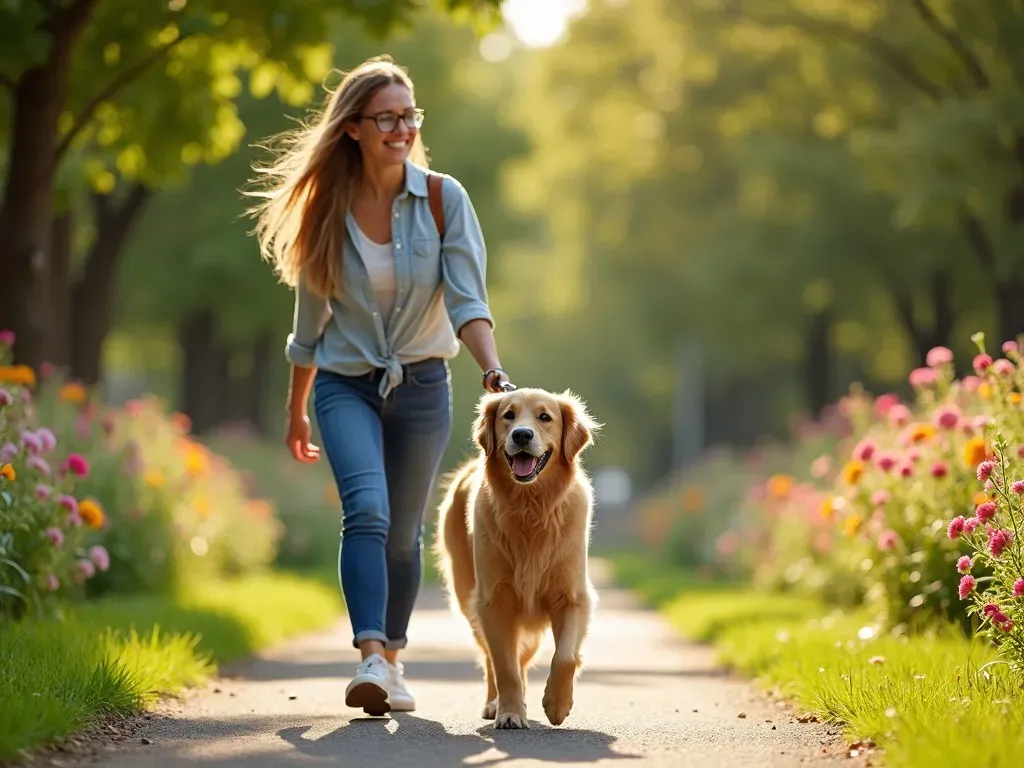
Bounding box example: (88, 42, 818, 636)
(474, 389, 600, 484)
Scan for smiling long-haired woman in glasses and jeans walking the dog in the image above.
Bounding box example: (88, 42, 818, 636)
(252, 57, 511, 715)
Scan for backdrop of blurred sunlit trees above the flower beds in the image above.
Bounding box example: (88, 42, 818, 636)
(0, 0, 1024, 563)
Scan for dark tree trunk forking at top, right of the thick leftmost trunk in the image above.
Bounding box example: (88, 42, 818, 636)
(71, 183, 151, 385)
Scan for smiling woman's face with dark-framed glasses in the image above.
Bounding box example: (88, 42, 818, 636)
(349, 83, 422, 165)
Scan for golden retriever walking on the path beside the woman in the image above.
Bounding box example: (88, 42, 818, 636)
(434, 388, 602, 729)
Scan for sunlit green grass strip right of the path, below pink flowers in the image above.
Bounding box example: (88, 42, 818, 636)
(611, 555, 1024, 768)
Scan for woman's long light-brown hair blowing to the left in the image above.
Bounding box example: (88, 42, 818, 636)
(245, 55, 427, 297)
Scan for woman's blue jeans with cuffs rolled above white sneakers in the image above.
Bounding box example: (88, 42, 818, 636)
(313, 358, 452, 650)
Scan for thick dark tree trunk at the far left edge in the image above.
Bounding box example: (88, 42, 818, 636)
(0, 0, 96, 368)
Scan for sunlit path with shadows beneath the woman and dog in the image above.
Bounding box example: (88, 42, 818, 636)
(79, 563, 863, 768)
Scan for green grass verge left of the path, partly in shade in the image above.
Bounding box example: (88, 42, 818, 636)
(0, 573, 342, 762)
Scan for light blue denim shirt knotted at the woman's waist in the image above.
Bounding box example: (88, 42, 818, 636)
(285, 161, 494, 397)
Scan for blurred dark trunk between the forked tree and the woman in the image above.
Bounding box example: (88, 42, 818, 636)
(178, 309, 230, 435)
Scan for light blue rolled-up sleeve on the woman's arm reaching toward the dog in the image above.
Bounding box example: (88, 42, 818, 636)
(441, 176, 495, 335)
